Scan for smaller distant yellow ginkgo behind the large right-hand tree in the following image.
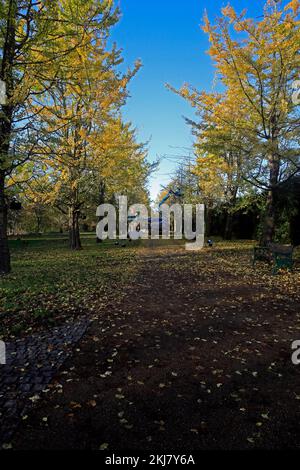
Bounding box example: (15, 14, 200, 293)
(192, 94, 254, 240)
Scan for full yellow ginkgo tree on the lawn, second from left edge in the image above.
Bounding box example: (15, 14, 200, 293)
(33, 2, 144, 250)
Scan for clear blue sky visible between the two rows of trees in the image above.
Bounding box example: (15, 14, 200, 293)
(112, 0, 263, 199)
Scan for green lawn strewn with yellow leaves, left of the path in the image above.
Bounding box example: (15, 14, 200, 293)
(0, 234, 140, 339)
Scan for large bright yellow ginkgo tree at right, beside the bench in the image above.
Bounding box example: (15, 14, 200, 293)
(172, 0, 300, 244)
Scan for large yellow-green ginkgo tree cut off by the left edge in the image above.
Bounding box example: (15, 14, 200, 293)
(0, 0, 120, 274)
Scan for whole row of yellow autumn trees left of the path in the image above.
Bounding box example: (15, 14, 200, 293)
(0, 0, 149, 273)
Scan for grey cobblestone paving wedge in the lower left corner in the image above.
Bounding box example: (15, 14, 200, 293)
(0, 319, 90, 449)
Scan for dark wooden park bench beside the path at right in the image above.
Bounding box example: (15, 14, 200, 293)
(252, 243, 293, 274)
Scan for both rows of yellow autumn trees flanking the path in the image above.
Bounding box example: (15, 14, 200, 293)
(0, 0, 300, 274)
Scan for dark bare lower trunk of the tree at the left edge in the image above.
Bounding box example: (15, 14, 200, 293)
(0, 172, 10, 274)
